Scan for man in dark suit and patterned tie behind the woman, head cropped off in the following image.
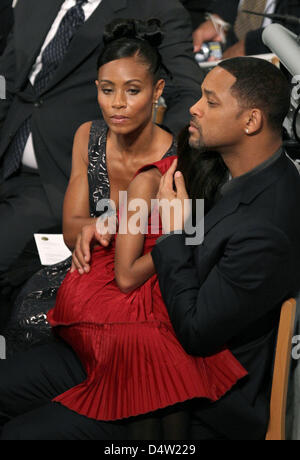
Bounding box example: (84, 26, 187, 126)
(0, 0, 202, 272)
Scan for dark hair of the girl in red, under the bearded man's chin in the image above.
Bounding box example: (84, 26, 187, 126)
(177, 127, 228, 213)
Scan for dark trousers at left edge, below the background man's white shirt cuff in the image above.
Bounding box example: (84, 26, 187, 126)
(0, 167, 58, 273)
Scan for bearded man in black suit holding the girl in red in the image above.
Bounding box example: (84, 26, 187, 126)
(152, 57, 300, 440)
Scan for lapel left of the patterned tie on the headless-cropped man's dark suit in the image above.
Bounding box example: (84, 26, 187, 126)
(16, 0, 64, 90)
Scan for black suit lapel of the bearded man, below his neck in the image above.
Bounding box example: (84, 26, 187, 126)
(204, 153, 290, 234)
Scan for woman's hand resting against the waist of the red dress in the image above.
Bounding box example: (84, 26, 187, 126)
(70, 218, 113, 275)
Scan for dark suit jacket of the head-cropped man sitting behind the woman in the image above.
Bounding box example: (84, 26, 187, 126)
(0, 0, 203, 219)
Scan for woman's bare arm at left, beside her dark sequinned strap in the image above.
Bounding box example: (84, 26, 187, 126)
(63, 122, 95, 251)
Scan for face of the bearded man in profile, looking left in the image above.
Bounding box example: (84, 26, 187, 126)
(189, 67, 244, 150)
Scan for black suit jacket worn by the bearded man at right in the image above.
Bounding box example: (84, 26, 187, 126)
(152, 154, 300, 439)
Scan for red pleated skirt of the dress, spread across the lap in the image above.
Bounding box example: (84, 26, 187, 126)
(48, 248, 247, 421)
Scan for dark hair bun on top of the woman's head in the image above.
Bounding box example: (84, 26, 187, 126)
(103, 18, 164, 47)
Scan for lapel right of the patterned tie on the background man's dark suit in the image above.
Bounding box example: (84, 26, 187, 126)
(41, 0, 127, 91)
